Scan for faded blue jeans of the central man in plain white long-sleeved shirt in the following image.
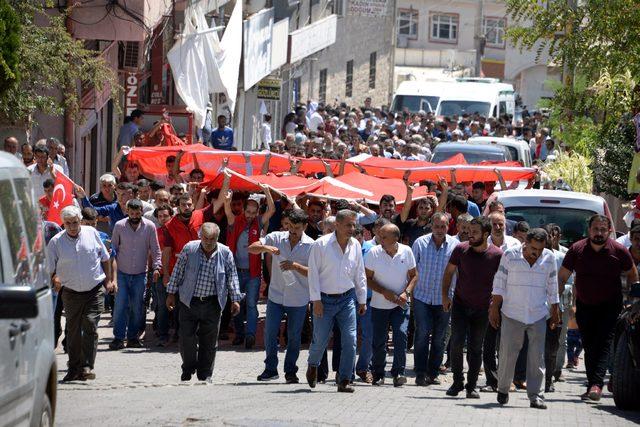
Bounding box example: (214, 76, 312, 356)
(308, 289, 357, 381)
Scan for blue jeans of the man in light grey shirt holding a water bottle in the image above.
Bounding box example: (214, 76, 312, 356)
(264, 300, 307, 374)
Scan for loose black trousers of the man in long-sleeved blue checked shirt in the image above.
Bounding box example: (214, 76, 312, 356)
(179, 296, 222, 380)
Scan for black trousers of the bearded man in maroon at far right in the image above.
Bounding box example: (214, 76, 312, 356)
(576, 298, 622, 388)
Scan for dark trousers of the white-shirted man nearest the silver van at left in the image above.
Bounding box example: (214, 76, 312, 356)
(62, 285, 104, 373)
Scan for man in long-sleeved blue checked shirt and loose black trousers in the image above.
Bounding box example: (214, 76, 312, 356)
(167, 222, 243, 382)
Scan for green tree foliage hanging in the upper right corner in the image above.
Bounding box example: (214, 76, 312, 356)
(506, 0, 640, 197)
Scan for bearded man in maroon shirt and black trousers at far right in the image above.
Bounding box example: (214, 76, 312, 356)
(558, 215, 638, 401)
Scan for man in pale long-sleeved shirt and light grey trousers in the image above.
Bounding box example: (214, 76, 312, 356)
(489, 228, 560, 409)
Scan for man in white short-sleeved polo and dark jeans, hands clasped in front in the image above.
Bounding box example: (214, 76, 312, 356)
(365, 224, 418, 387)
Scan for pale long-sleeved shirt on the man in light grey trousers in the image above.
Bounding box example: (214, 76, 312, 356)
(492, 246, 560, 325)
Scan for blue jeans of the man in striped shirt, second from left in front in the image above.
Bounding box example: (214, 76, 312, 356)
(113, 271, 147, 340)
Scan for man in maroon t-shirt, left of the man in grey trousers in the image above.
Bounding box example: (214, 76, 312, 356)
(442, 217, 502, 399)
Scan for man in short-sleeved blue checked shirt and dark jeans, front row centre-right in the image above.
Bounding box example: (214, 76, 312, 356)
(412, 212, 459, 386)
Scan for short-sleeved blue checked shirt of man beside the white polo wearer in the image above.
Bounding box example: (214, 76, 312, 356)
(412, 233, 459, 305)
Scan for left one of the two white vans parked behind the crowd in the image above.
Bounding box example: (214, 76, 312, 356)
(391, 80, 453, 113)
